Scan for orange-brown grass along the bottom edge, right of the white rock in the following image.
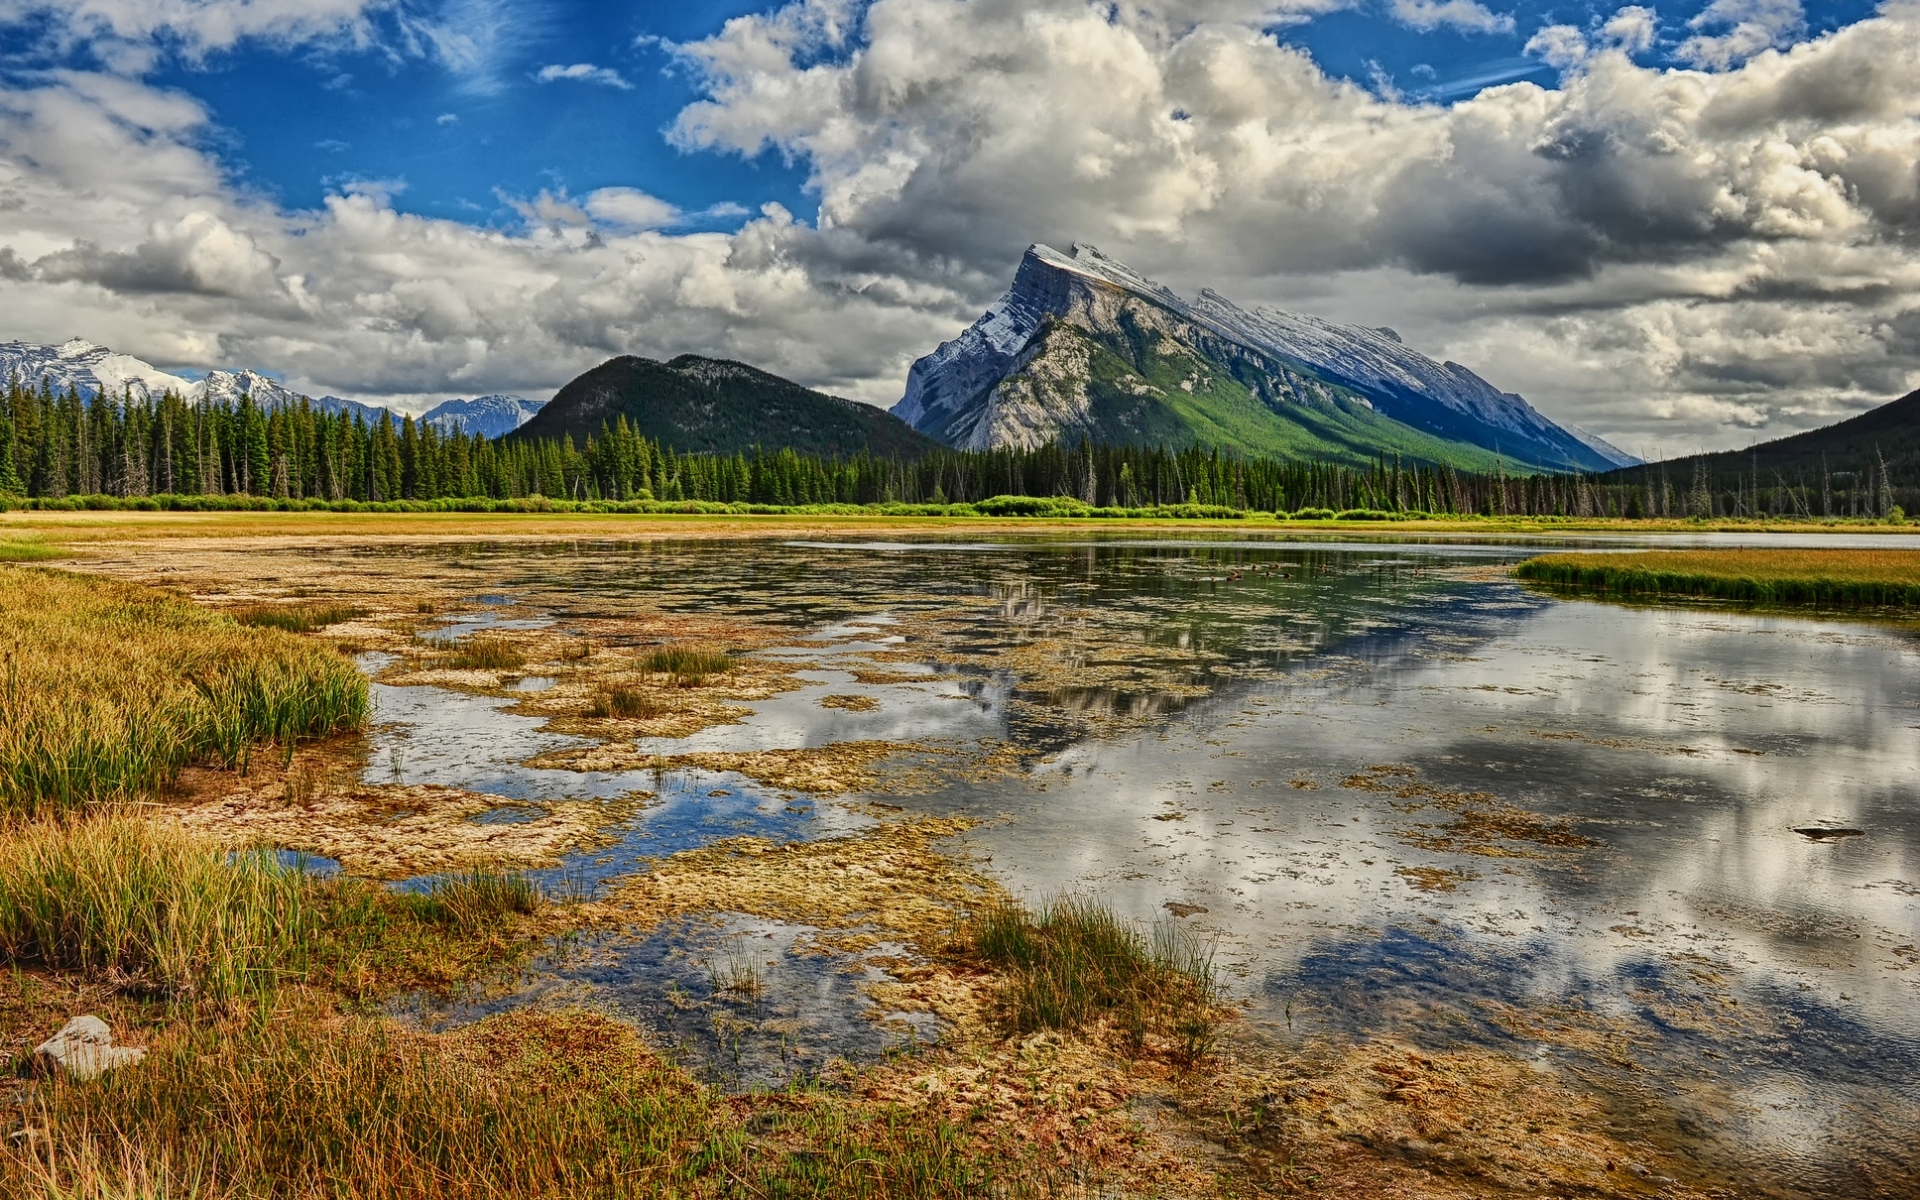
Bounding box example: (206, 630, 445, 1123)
(11, 1012, 1006, 1200)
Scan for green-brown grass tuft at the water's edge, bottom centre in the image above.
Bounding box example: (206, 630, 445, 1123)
(956, 897, 1219, 1066)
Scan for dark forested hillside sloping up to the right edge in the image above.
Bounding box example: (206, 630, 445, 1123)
(1597, 392, 1920, 516)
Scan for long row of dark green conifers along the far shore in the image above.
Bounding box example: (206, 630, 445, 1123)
(0, 380, 1912, 516)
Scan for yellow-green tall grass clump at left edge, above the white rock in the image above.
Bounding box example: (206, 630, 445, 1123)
(0, 812, 309, 1000)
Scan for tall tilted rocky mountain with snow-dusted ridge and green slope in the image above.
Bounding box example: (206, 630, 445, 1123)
(893, 246, 1636, 470)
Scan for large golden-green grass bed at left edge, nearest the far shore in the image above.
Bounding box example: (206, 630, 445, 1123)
(0, 568, 369, 816)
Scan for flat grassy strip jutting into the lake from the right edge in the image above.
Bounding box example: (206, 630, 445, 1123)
(1515, 549, 1920, 609)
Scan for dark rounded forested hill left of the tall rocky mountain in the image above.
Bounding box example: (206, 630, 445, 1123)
(515, 353, 937, 455)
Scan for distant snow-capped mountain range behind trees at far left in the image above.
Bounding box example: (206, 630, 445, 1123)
(0, 338, 540, 438)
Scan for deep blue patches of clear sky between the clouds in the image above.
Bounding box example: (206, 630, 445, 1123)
(112, 0, 1872, 228)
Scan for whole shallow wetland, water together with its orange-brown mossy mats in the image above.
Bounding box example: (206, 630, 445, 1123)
(8, 518, 1920, 1196)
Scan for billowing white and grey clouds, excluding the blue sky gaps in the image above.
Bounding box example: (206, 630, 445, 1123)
(0, 0, 1920, 449)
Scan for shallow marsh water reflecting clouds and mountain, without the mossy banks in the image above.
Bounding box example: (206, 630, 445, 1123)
(359, 536, 1920, 1196)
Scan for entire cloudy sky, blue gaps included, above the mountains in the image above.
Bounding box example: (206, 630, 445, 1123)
(0, 0, 1920, 453)
